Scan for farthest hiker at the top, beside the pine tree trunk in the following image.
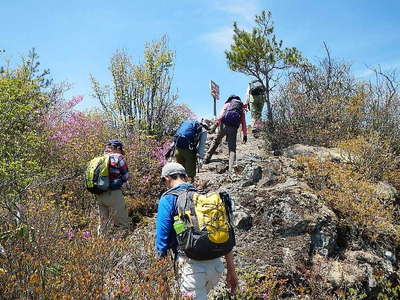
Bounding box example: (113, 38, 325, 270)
(246, 80, 265, 134)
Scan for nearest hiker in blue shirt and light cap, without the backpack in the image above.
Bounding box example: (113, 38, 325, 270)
(156, 162, 238, 300)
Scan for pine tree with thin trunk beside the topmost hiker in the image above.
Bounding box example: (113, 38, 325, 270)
(225, 11, 301, 130)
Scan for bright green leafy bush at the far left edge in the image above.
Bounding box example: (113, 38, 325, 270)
(0, 61, 48, 209)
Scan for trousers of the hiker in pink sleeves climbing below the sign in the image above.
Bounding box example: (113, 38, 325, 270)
(205, 123, 238, 172)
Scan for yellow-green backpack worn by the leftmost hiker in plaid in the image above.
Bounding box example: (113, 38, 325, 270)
(85, 154, 110, 194)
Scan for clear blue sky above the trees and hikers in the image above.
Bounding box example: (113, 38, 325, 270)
(0, 0, 400, 116)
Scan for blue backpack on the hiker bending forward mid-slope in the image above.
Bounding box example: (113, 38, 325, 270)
(174, 120, 201, 150)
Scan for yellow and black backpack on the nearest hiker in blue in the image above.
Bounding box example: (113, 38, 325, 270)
(168, 188, 235, 260)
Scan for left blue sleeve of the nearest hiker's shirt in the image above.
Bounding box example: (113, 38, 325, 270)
(156, 195, 175, 257)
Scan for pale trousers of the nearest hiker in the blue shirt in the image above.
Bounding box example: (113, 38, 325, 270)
(177, 257, 225, 300)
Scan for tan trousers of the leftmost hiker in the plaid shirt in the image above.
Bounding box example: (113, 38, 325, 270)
(96, 190, 130, 235)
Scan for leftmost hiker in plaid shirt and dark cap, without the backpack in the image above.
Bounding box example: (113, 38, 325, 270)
(96, 139, 130, 234)
